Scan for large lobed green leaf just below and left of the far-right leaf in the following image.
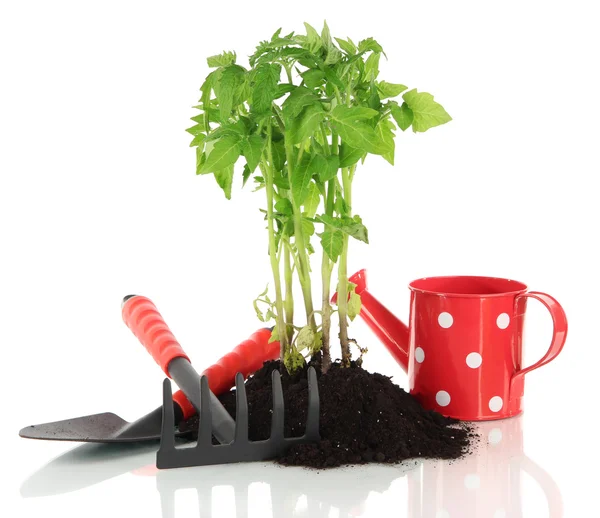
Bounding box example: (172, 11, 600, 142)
(331, 105, 390, 155)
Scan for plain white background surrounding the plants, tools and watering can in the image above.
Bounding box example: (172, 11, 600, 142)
(0, 0, 600, 518)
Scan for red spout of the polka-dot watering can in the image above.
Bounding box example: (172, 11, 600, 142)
(333, 270, 409, 372)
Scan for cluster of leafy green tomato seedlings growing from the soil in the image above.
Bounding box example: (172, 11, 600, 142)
(187, 24, 451, 371)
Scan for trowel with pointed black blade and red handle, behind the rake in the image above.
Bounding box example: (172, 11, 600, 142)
(19, 297, 279, 443)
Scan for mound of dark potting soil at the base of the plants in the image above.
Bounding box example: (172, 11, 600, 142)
(179, 361, 476, 468)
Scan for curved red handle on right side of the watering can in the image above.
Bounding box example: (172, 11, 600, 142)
(510, 291, 568, 399)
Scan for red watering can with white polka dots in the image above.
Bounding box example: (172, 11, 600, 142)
(333, 270, 567, 421)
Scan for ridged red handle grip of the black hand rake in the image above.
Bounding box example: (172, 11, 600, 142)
(121, 295, 190, 376)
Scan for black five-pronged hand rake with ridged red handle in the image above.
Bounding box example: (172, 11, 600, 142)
(123, 296, 319, 469)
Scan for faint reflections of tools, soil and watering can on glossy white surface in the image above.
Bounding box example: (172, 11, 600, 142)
(21, 417, 563, 518)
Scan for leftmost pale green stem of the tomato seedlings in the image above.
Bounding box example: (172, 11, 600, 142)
(261, 123, 288, 365)
